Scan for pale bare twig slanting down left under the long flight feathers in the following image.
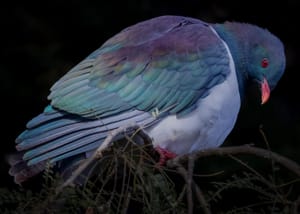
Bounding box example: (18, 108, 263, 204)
(56, 123, 140, 194)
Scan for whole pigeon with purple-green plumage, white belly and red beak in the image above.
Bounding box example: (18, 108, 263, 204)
(8, 15, 286, 184)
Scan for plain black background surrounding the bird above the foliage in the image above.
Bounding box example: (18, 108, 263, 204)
(0, 0, 300, 186)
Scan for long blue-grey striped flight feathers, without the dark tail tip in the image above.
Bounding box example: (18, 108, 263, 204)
(16, 110, 156, 166)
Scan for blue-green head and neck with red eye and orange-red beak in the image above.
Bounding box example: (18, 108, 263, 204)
(212, 22, 285, 104)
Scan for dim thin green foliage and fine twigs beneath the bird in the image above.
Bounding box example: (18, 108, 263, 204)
(0, 136, 300, 214)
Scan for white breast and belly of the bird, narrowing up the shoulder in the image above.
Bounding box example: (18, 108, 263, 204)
(148, 29, 240, 154)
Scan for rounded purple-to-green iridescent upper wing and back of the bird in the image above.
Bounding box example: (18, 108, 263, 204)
(49, 16, 229, 118)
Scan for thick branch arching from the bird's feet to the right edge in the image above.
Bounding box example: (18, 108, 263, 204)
(167, 145, 300, 176)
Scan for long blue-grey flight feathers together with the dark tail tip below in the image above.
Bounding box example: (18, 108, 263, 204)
(8, 106, 156, 184)
